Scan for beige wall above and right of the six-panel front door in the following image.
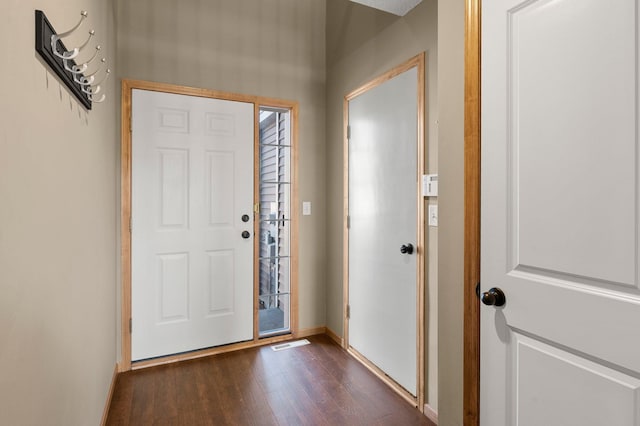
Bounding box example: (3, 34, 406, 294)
(117, 0, 326, 329)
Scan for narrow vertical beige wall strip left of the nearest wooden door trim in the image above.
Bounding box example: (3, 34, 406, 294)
(438, 0, 465, 426)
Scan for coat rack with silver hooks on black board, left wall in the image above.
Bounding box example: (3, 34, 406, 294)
(36, 10, 111, 109)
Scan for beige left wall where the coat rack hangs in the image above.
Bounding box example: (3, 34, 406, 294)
(0, 0, 117, 425)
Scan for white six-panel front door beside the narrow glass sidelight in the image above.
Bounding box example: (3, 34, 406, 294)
(131, 90, 254, 361)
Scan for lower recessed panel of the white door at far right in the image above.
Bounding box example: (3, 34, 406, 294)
(509, 333, 640, 426)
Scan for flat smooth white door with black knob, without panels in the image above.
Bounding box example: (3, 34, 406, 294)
(348, 67, 418, 396)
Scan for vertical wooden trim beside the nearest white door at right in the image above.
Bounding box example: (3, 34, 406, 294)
(463, 0, 482, 426)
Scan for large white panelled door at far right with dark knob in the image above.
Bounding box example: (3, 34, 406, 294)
(480, 0, 640, 426)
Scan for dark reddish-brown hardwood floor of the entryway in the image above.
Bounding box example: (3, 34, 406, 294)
(107, 335, 434, 426)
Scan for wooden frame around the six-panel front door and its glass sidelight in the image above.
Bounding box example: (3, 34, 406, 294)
(118, 79, 300, 372)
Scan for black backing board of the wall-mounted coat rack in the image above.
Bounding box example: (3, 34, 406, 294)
(36, 10, 91, 109)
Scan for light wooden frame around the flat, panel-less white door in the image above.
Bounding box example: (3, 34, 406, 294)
(342, 52, 427, 411)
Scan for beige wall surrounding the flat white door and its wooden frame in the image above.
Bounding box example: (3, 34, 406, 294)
(327, 0, 438, 410)
